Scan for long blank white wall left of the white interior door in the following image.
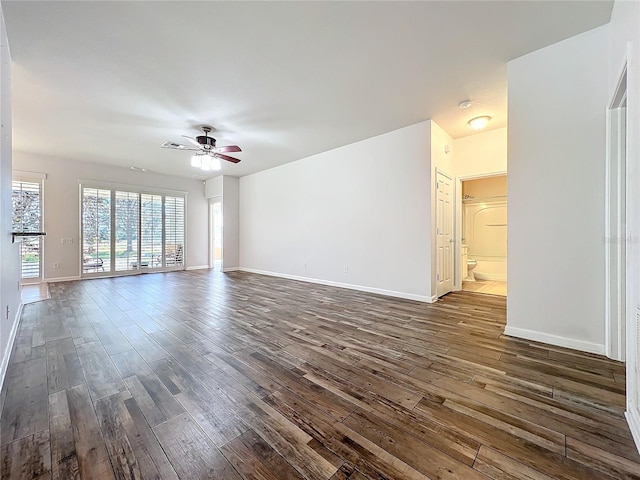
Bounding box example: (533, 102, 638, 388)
(240, 121, 431, 300)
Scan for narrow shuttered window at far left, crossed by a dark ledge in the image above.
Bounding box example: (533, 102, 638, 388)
(11, 180, 42, 282)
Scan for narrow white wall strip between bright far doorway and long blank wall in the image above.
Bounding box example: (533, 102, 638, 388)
(222, 175, 240, 272)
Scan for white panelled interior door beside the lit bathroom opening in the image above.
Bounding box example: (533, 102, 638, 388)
(436, 171, 455, 297)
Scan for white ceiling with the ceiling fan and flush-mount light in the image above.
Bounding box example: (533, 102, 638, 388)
(2, 0, 613, 177)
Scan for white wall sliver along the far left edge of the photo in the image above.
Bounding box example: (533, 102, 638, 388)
(0, 6, 20, 388)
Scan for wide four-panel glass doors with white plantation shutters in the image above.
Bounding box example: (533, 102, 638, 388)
(82, 186, 185, 276)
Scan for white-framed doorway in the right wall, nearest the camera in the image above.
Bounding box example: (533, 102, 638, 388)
(605, 65, 637, 361)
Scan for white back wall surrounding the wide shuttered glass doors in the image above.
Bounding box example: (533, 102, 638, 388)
(13, 152, 209, 280)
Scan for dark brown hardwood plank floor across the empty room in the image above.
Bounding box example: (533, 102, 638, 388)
(0, 271, 640, 480)
